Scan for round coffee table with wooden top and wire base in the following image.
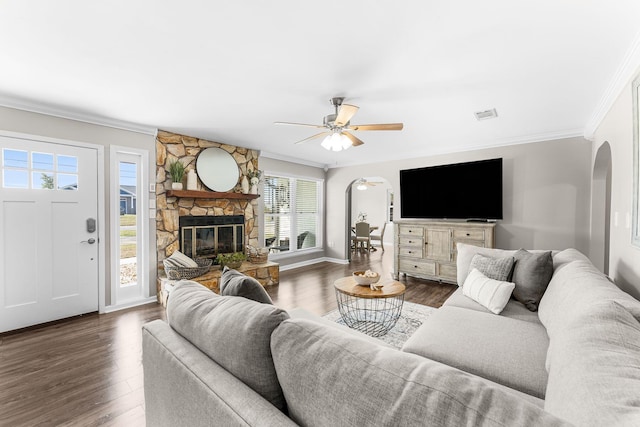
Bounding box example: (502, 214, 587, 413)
(333, 276, 406, 337)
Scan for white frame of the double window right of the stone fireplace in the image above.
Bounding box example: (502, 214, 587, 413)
(260, 170, 325, 260)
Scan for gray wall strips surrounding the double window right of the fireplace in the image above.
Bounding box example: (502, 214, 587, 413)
(258, 155, 326, 267)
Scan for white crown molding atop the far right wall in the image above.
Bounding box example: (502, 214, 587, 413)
(584, 32, 640, 141)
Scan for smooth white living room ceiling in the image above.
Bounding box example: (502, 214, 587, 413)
(0, 0, 640, 167)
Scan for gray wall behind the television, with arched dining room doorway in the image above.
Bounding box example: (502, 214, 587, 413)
(326, 138, 591, 259)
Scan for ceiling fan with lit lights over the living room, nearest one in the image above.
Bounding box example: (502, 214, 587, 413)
(275, 97, 403, 151)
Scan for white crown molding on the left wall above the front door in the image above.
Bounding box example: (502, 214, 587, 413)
(0, 94, 158, 136)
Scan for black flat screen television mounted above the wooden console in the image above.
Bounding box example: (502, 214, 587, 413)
(400, 158, 502, 220)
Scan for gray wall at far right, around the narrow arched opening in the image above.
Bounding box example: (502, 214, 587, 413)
(593, 67, 640, 299)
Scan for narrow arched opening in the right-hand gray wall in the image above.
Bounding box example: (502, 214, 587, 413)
(590, 141, 612, 274)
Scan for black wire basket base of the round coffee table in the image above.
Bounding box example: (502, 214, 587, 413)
(336, 289, 404, 337)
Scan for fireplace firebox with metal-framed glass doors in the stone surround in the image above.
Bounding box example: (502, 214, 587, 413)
(179, 215, 244, 259)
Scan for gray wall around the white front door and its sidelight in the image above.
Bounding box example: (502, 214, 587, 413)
(0, 107, 157, 305)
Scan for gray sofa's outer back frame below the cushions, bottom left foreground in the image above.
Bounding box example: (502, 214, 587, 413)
(141, 320, 297, 427)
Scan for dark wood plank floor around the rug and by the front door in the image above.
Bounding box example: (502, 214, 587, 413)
(0, 250, 455, 427)
